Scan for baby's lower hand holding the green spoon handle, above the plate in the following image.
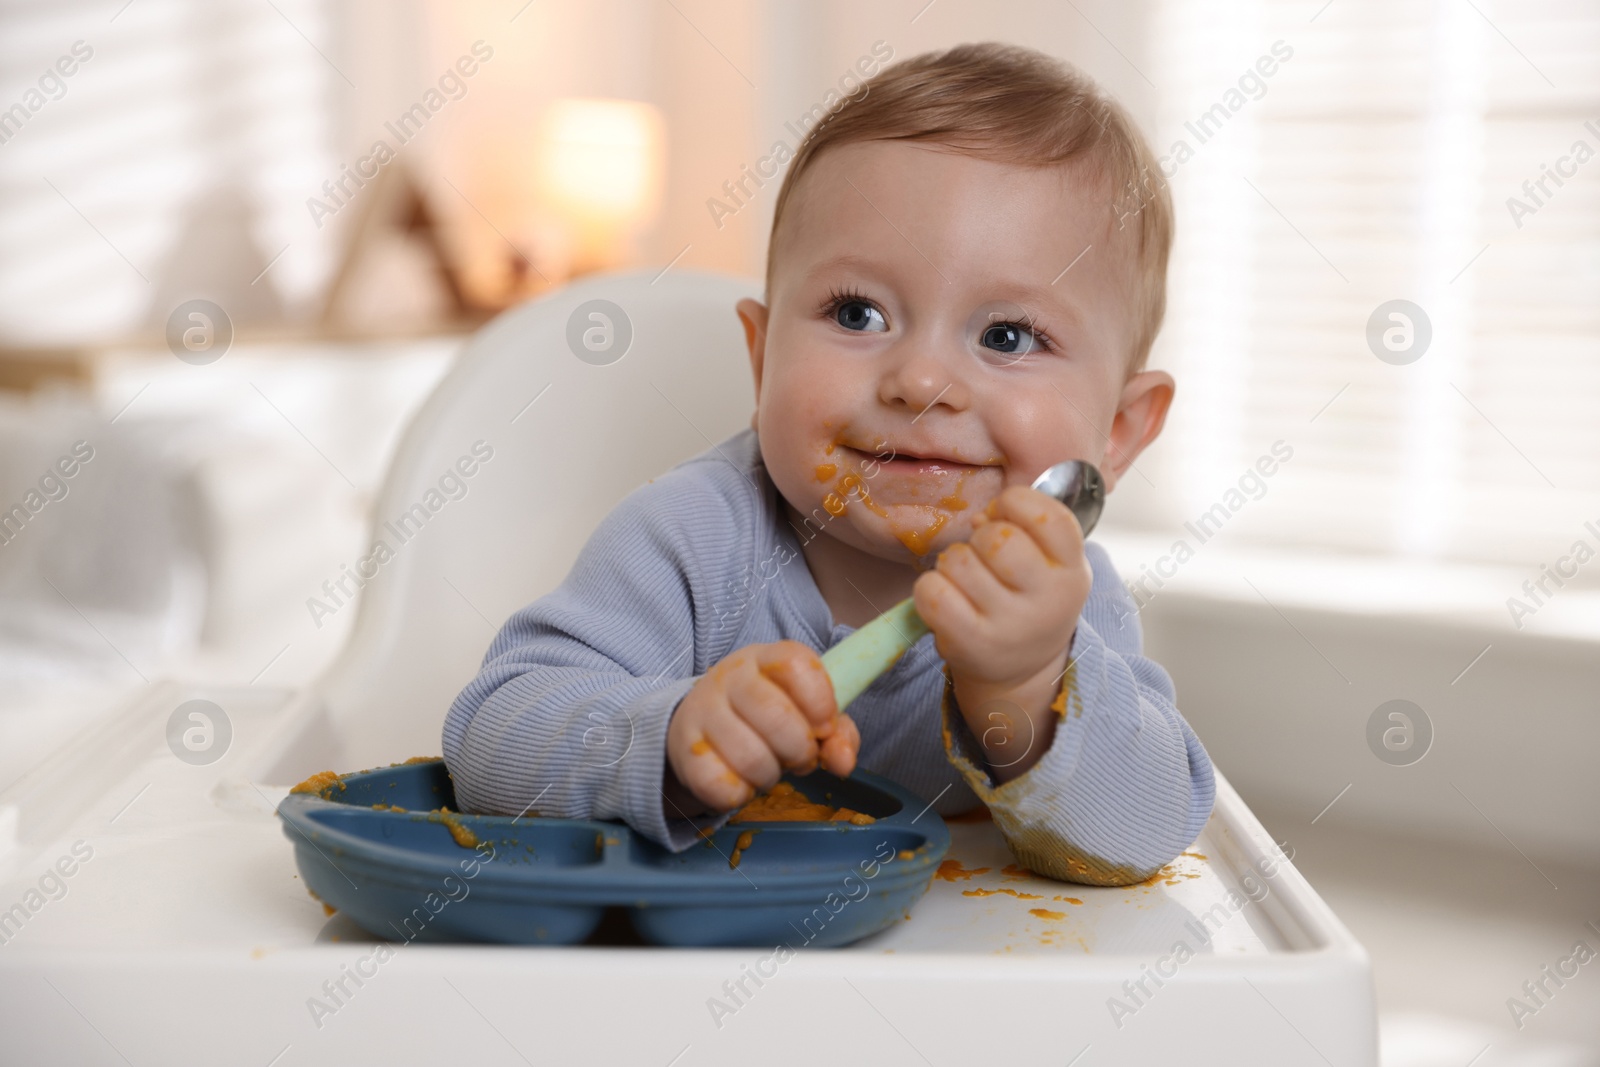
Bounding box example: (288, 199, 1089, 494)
(667, 641, 861, 811)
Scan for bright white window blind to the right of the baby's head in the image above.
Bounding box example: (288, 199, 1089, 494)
(1118, 0, 1600, 581)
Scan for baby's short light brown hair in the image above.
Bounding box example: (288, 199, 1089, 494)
(766, 42, 1173, 374)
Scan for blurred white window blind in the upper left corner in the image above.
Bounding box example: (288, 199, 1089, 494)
(0, 0, 337, 346)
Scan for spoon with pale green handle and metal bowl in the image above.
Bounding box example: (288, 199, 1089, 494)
(822, 459, 1106, 712)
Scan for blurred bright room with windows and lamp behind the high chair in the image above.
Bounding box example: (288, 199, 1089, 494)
(0, 0, 1600, 1067)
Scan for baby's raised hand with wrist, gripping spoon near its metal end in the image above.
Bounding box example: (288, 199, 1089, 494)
(912, 485, 1094, 779)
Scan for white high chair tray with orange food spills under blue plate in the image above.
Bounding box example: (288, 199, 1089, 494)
(0, 686, 1376, 1067)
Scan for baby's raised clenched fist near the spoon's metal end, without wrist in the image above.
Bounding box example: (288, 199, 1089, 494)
(912, 485, 1094, 691)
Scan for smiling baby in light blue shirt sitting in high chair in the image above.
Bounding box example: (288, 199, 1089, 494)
(443, 45, 1216, 885)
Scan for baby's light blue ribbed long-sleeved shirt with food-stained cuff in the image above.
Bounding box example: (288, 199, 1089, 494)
(443, 430, 1216, 885)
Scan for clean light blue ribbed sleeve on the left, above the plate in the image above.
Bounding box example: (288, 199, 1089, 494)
(443, 477, 742, 851)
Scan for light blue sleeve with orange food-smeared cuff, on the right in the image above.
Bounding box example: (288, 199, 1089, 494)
(939, 544, 1216, 885)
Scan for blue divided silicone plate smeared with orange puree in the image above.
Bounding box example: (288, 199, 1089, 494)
(278, 760, 950, 949)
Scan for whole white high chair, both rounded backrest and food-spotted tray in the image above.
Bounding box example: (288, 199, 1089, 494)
(0, 270, 1376, 1067)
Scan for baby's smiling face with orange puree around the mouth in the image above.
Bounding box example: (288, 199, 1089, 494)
(739, 141, 1171, 566)
